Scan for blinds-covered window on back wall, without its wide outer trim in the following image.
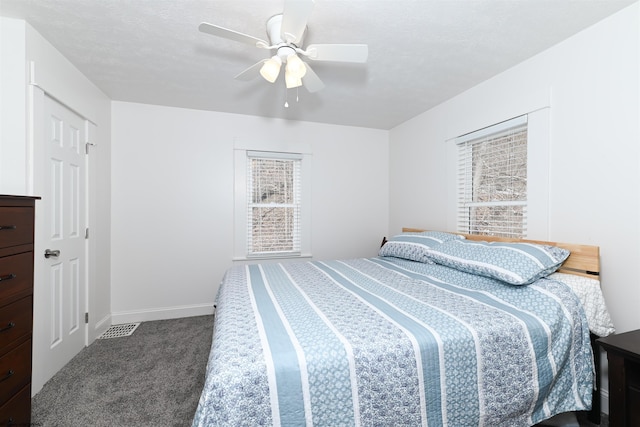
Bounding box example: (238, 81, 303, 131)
(247, 152, 302, 256)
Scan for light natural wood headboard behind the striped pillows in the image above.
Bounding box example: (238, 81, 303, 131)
(402, 227, 600, 278)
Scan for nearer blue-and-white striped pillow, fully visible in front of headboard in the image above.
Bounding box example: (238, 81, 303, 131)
(427, 240, 569, 285)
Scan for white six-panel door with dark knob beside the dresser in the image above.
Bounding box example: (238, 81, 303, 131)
(36, 96, 86, 378)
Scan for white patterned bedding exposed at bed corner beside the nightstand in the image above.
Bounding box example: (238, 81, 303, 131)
(548, 273, 615, 337)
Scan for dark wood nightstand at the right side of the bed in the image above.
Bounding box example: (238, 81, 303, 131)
(598, 330, 640, 427)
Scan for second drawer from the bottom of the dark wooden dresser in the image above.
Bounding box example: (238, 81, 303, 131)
(0, 340, 31, 404)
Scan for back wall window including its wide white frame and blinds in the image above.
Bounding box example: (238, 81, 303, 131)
(233, 143, 312, 262)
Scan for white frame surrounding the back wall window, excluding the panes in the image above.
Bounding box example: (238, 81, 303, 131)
(233, 144, 312, 261)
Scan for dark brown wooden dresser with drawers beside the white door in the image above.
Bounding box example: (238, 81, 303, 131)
(0, 195, 36, 426)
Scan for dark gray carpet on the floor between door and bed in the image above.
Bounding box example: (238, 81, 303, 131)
(31, 316, 213, 427)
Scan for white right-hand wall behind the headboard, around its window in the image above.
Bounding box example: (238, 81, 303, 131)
(389, 3, 640, 408)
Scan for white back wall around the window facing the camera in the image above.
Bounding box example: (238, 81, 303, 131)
(111, 102, 389, 323)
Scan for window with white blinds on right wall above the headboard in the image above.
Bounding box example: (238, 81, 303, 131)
(456, 116, 527, 238)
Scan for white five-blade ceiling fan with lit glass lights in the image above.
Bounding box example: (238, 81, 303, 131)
(198, 0, 369, 92)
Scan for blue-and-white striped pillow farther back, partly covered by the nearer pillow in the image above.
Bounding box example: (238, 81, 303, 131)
(378, 231, 464, 264)
